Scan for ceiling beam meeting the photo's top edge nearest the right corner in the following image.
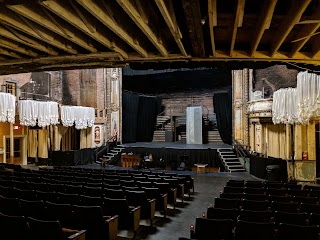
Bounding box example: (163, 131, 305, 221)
(271, 0, 311, 57)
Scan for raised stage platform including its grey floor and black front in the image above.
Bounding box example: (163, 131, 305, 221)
(119, 142, 232, 170)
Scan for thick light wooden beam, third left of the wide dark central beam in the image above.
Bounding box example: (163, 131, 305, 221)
(77, 0, 148, 57)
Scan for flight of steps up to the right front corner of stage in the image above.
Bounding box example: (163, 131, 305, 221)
(217, 148, 246, 172)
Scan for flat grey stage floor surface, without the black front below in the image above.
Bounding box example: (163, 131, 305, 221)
(120, 142, 232, 149)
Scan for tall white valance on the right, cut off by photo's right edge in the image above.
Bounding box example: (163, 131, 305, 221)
(297, 72, 320, 124)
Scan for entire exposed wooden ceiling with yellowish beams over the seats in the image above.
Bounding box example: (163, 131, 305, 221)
(0, 0, 320, 74)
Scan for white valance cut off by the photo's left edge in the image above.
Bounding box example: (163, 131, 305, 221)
(0, 92, 16, 123)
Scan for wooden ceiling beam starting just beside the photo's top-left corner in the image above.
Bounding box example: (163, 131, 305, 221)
(8, 5, 97, 52)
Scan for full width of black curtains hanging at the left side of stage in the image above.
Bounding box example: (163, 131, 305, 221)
(122, 92, 162, 143)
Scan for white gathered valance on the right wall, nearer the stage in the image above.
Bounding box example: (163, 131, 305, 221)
(272, 88, 299, 124)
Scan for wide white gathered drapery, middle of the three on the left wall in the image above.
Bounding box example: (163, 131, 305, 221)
(19, 100, 59, 127)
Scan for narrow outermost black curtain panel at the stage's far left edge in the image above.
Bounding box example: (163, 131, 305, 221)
(122, 92, 139, 143)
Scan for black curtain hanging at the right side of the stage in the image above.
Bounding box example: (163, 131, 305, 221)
(213, 89, 232, 144)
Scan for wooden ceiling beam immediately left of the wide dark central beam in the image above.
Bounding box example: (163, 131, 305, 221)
(155, 0, 187, 56)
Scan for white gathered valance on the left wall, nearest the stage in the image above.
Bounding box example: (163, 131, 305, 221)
(60, 106, 95, 129)
